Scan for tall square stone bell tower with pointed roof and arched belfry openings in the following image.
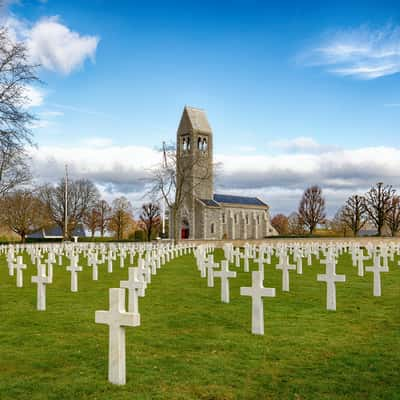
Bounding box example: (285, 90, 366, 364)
(176, 106, 214, 238)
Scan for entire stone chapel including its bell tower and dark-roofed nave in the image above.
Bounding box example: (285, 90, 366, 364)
(170, 106, 277, 240)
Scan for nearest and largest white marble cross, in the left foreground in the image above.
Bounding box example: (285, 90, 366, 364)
(95, 288, 140, 385)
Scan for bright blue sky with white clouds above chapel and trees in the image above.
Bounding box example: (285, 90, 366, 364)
(4, 0, 400, 213)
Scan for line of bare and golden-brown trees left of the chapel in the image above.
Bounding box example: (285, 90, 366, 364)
(0, 179, 160, 241)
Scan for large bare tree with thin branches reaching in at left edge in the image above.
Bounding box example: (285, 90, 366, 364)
(0, 28, 38, 195)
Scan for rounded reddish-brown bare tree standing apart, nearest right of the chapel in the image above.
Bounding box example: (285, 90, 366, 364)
(298, 185, 326, 235)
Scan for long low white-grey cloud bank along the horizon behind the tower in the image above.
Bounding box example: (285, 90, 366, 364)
(31, 138, 400, 215)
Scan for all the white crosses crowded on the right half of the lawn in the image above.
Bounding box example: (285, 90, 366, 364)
(195, 243, 400, 334)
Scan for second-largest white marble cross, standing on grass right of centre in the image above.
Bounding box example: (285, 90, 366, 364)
(240, 271, 275, 335)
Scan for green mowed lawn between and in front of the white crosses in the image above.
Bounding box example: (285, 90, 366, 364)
(0, 251, 400, 400)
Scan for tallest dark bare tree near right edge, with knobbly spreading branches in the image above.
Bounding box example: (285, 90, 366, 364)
(364, 182, 396, 236)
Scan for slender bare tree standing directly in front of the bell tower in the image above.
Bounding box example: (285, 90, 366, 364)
(148, 146, 216, 240)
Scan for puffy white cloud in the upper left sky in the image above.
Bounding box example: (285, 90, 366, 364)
(3, 16, 100, 75)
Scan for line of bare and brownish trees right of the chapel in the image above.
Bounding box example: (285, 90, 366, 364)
(271, 182, 400, 236)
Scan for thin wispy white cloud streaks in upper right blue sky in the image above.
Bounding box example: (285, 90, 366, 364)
(298, 24, 400, 79)
